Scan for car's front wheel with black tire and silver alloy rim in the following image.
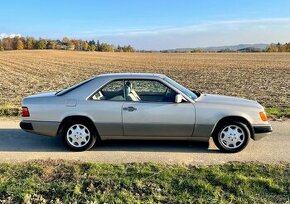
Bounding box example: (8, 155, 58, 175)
(213, 121, 251, 153)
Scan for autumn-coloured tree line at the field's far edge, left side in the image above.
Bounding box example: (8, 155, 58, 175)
(0, 37, 135, 52)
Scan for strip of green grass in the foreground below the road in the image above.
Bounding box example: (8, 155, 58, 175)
(0, 161, 290, 203)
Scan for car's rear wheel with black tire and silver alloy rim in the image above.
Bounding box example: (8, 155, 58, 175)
(61, 119, 97, 151)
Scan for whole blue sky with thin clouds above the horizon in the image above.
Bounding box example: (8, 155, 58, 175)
(0, 0, 290, 49)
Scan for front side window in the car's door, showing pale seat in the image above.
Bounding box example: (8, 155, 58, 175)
(125, 80, 176, 102)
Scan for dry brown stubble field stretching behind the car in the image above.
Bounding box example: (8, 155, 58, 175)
(0, 50, 290, 107)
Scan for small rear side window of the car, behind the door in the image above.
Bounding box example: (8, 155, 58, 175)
(92, 80, 124, 101)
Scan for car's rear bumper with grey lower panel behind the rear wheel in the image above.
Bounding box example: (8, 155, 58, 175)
(19, 120, 60, 136)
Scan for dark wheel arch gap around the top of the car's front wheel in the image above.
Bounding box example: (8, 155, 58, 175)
(211, 116, 254, 138)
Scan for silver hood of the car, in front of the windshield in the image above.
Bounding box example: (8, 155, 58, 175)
(196, 94, 262, 108)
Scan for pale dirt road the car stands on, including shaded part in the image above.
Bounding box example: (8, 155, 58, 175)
(0, 118, 290, 164)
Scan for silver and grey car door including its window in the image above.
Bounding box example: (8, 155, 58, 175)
(122, 80, 195, 137)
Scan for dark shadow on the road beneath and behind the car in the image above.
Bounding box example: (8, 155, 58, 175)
(0, 129, 219, 153)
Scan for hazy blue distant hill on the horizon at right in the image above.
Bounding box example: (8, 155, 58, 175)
(164, 43, 269, 52)
